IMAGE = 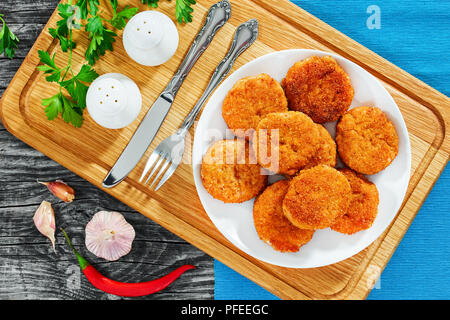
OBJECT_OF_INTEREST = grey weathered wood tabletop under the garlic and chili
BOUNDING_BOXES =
[0,0,214,299]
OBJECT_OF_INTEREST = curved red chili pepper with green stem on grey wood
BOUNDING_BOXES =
[60,228,195,297]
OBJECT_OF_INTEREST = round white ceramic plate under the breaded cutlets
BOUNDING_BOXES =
[192,49,411,268]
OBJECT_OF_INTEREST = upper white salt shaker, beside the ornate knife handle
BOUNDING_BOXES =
[123,10,179,66]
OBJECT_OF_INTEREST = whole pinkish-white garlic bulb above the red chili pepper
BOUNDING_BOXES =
[85,211,135,261]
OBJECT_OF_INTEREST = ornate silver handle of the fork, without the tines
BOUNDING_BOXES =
[179,19,258,133]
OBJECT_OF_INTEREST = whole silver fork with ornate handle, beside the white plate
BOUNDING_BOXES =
[139,19,258,191]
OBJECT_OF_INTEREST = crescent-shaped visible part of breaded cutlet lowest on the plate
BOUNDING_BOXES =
[253,180,314,252]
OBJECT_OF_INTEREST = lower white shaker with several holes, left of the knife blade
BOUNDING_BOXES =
[86,73,142,129]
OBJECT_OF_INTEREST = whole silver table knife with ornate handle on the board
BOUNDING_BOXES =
[102,0,231,188]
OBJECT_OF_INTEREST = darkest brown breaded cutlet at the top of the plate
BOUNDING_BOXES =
[281,56,354,123]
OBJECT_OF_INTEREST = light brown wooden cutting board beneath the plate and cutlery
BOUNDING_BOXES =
[0,0,450,299]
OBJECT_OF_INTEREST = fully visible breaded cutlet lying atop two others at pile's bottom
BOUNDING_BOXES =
[283,165,351,230]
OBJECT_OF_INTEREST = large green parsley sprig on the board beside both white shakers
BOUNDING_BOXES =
[37,0,138,127]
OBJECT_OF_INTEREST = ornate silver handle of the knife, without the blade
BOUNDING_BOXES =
[163,0,231,101]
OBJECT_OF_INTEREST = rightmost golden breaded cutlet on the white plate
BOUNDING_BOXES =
[336,106,398,174]
